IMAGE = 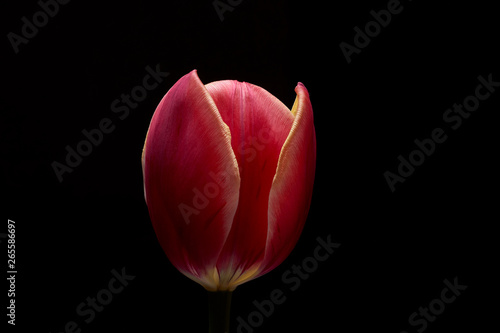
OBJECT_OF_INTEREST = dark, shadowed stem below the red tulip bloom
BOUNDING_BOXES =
[208,291,233,333]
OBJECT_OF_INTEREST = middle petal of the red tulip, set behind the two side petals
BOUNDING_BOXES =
[206,81,294,289]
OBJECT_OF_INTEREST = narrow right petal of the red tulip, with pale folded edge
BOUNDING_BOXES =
[258,82,316,276]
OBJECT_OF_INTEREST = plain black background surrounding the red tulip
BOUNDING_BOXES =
[0,0,500,333]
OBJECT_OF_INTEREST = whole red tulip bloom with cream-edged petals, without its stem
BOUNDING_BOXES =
[142,70,316,332]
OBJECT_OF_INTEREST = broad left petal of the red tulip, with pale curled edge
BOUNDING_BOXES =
[143,70,240,290]
